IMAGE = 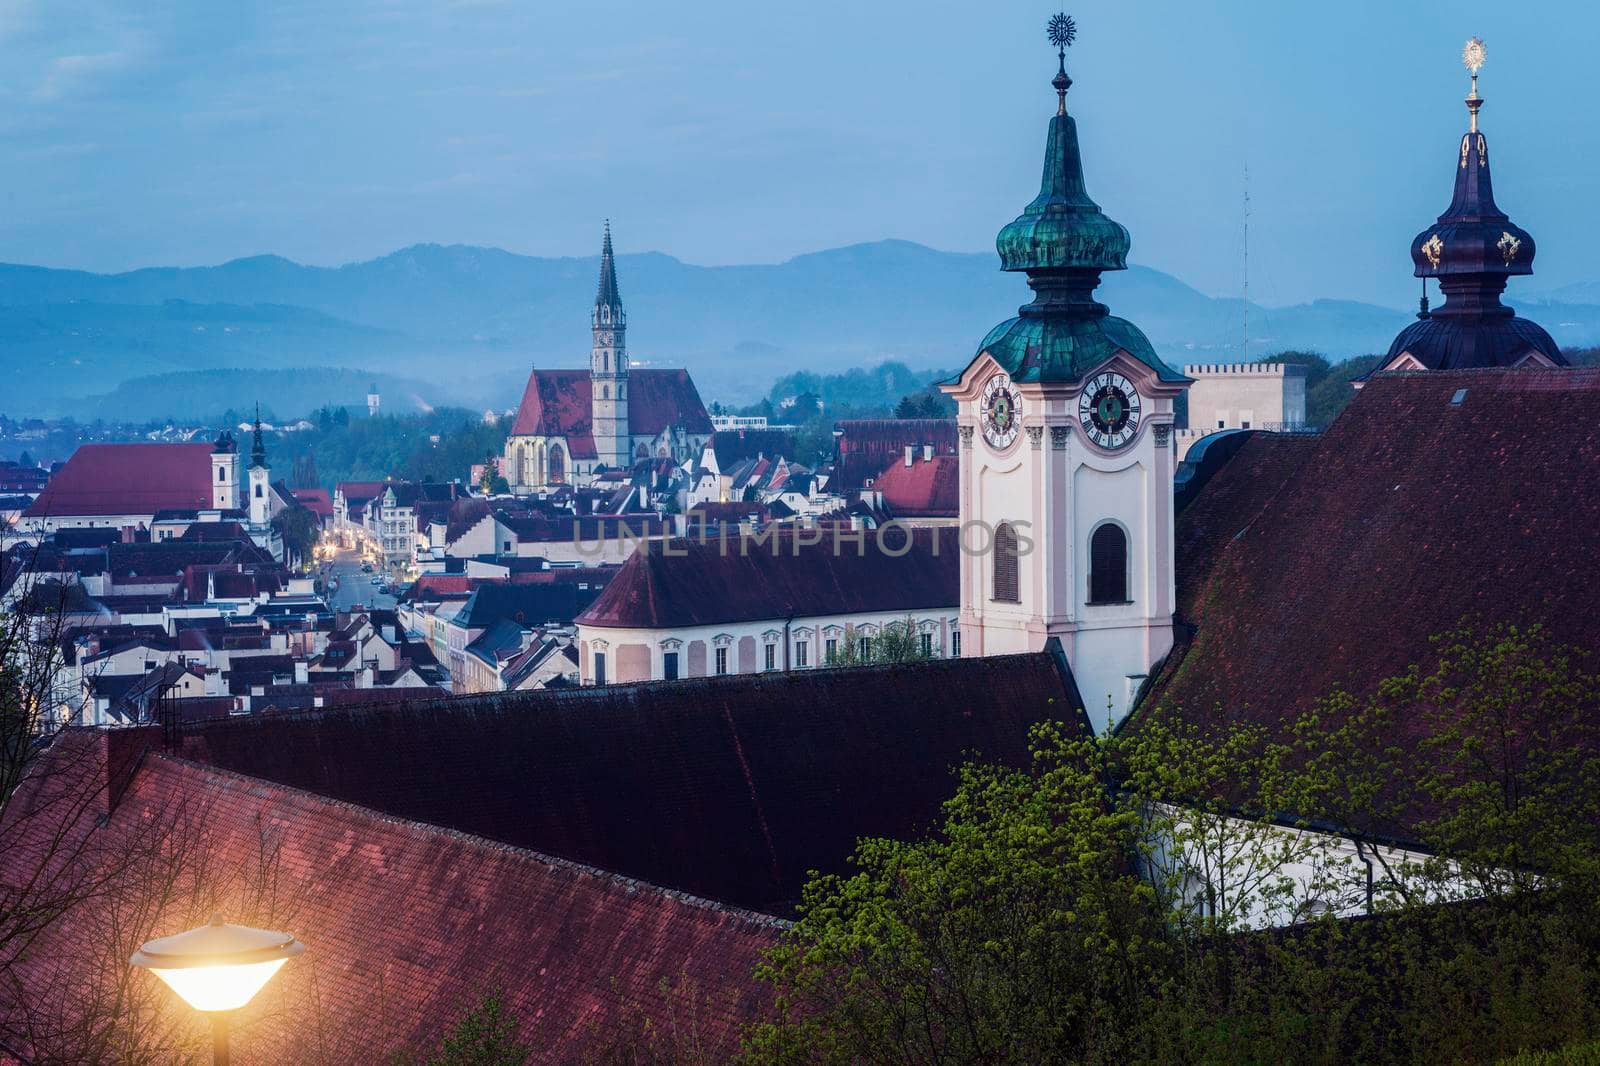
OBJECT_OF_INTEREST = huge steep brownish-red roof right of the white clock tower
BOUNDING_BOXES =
[1134,370,1600,832]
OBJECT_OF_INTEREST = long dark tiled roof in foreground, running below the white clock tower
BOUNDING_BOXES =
[168,653,1077,915]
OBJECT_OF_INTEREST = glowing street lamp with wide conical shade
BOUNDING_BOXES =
[130,914,306,1066]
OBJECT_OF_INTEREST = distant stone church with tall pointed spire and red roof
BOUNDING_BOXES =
[502,222,712,493]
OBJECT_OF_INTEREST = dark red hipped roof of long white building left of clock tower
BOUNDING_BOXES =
[578,528,962,629]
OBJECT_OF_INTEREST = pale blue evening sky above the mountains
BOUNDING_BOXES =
[0,0,1600,307]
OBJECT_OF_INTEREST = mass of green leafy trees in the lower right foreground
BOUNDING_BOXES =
[746,626,1600,1063]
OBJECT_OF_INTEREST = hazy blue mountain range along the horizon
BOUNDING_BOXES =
[0,240,1600,416]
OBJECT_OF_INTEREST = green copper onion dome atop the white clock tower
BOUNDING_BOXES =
[978,36,1187,383]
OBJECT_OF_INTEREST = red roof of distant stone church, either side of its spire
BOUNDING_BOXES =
[510,370,710,459]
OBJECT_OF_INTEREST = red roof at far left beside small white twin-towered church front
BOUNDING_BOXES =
[22,443,211,519]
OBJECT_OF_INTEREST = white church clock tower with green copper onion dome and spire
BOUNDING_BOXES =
[941,14,1190,730]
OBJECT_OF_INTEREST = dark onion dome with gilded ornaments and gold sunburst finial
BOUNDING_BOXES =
[1381,42,1566,370]
